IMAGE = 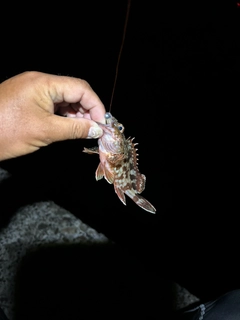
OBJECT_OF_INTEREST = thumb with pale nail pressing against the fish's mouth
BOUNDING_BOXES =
[44,114,103,142]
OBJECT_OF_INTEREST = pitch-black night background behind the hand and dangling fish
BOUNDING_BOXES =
[0,0,240,310]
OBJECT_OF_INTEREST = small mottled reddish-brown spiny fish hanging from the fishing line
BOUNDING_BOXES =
[83,112,156,213]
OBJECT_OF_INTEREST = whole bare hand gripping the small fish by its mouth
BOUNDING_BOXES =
[0,71,106,160]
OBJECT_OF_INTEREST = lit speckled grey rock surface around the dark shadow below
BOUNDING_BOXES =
[0,168,198,320]
